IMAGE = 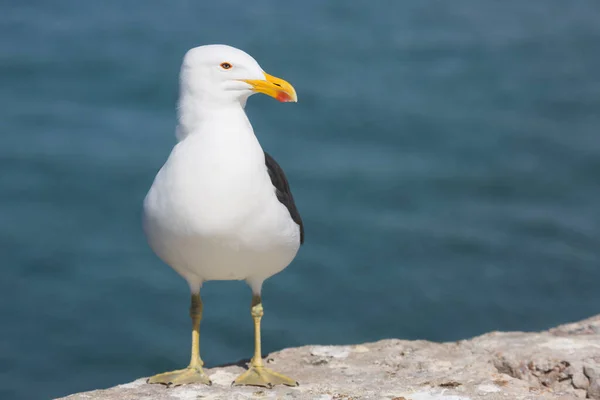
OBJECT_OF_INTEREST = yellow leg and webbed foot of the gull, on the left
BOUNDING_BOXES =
[147,294,211,386]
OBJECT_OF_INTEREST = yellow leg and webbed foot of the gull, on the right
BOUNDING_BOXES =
[233,295,298,388]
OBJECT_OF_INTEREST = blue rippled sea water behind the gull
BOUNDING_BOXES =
[0,0,600,399]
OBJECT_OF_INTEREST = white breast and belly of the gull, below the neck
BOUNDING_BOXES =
[144,115,300,287]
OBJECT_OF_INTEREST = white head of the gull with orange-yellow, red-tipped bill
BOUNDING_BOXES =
[180,44,298,107]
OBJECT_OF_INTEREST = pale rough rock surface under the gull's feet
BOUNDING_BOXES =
[57,315,600,400]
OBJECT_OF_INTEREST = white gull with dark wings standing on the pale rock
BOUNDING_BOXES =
[143,45,304,388]
